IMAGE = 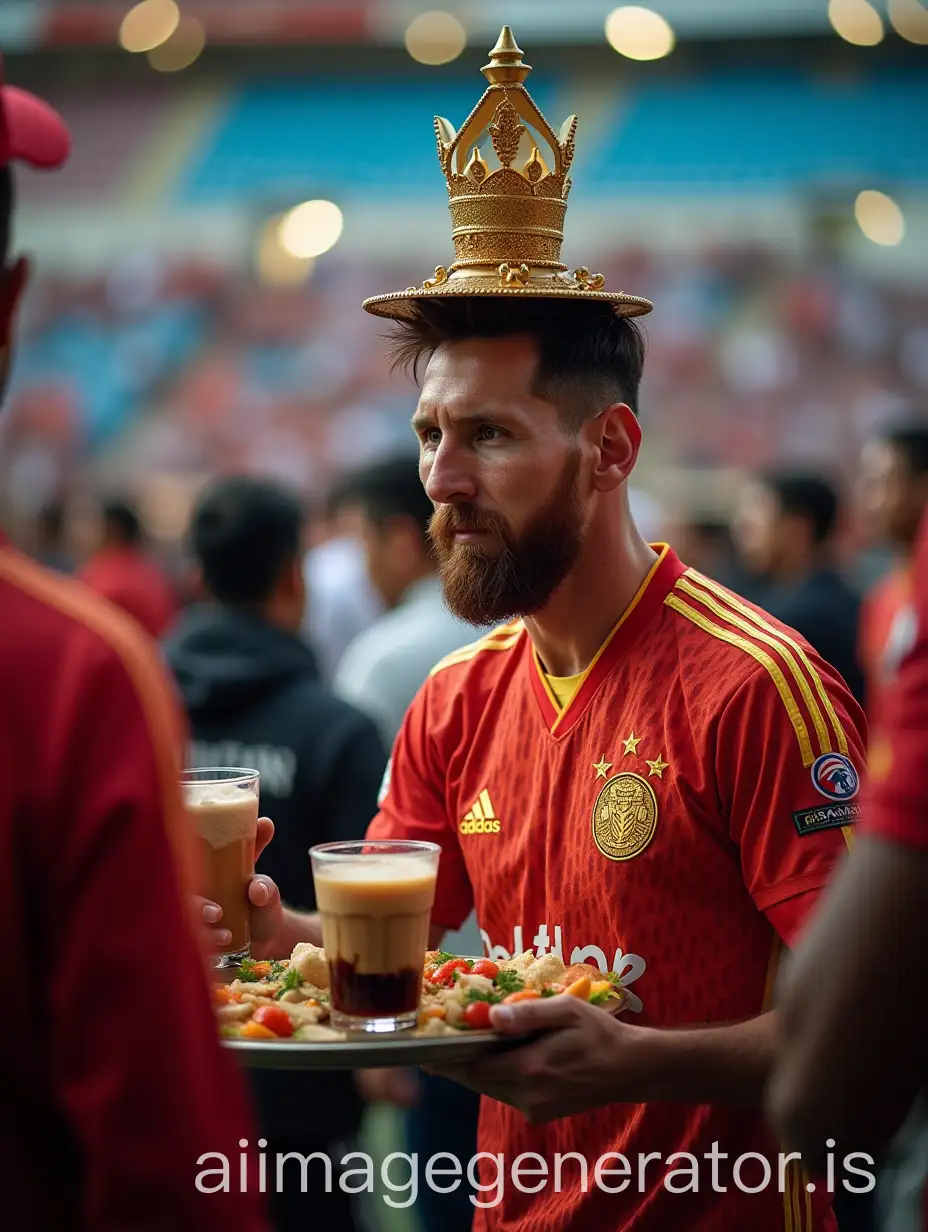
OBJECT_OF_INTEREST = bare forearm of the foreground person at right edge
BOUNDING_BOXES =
[768,835,928,1162]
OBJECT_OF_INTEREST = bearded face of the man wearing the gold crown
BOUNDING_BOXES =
[413,338,587,625]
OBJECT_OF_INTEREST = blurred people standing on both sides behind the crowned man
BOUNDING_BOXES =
[10,408,928,1232]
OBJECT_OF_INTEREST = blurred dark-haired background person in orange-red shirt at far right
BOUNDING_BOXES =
[858,421,928,731]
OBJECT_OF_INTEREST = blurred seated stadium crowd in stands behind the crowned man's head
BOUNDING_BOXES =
[7,244,928,529]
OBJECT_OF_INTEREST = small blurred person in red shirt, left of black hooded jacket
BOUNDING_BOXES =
[78,498,177,638]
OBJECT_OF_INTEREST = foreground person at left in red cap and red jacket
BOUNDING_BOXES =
[0,52,266,1232]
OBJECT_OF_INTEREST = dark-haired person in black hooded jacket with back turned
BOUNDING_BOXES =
[164,476,387,1232]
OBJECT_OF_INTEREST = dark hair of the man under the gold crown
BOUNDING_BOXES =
[391,296,645,431]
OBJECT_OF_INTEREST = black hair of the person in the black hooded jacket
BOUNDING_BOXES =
[189,476,304,606]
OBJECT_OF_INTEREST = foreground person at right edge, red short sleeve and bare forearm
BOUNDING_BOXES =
[768,505,928,1228]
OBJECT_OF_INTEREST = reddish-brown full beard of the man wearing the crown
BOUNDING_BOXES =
[429,450,584,625]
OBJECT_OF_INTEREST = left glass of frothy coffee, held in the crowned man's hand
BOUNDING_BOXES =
[181,766,259,970]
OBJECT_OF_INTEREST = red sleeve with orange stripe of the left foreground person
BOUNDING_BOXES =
[48,634,266,1232]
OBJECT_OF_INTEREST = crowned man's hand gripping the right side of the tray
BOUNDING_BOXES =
[425,995,656,1125]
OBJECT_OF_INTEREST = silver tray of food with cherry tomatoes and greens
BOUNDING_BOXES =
[213,942,626,1069]
